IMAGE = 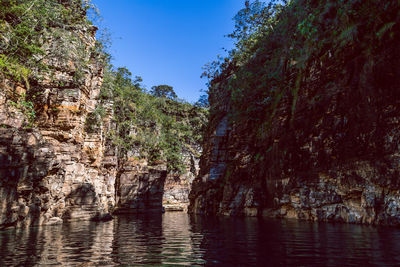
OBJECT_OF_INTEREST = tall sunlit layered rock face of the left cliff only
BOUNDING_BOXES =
[0,5,117,227]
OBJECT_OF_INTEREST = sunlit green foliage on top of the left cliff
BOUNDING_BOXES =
[0,0,97,127]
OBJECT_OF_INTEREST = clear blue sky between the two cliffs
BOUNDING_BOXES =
[92,0,244,102]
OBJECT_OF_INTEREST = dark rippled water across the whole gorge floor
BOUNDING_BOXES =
[0,213,400,266]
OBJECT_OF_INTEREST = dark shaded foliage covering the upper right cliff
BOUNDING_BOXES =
[205,0,400,180]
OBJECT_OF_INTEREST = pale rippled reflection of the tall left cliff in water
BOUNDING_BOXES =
[0,221,114,266]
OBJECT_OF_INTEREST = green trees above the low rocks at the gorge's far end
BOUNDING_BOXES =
[98,68,207,172]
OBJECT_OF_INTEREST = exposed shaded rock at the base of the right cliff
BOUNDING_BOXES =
[190,103,400,225]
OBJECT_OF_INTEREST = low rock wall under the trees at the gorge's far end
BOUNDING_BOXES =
[114,152,199,214]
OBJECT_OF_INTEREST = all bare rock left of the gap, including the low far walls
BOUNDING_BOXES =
[0,1,203,228]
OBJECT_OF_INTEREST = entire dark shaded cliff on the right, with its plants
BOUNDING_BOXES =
[189,1,400,225]
